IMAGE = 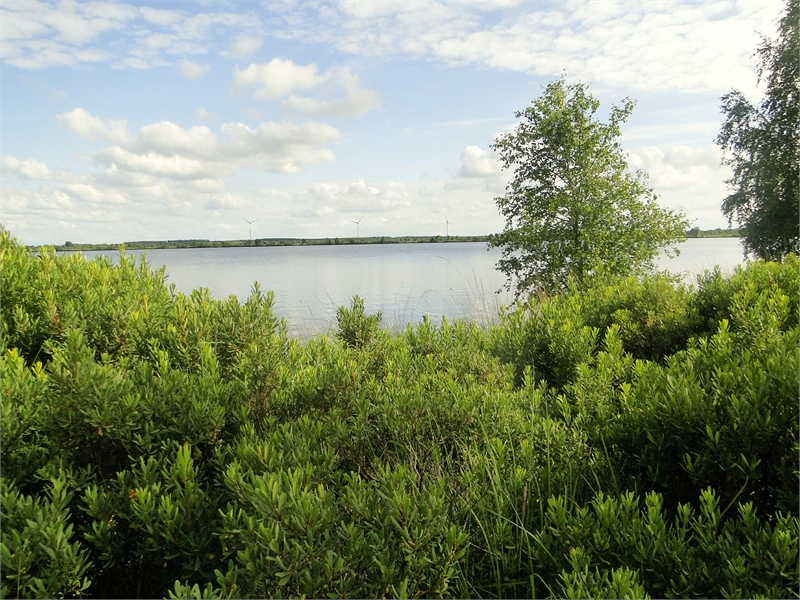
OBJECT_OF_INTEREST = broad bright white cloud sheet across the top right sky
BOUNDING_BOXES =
[268,0,783,94]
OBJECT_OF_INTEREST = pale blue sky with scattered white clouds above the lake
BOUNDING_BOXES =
[0,0,783,244]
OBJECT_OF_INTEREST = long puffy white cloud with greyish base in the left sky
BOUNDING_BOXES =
[58,108,341,180]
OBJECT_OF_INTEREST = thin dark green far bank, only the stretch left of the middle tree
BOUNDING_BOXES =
[50,235,490,252]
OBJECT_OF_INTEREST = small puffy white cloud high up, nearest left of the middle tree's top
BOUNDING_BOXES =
[234,58,381,118]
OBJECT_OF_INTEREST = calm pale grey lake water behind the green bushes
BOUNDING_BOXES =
[73,238,744,338]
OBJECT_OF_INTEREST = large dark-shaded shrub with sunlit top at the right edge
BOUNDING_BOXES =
[592,321,799,513]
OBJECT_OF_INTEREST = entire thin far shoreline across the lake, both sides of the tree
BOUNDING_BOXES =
[36,227,741,252]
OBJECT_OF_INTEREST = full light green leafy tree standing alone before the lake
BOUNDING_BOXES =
[490,77,688,294]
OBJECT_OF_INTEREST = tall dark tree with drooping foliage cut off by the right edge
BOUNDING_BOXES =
[716,0,800,260]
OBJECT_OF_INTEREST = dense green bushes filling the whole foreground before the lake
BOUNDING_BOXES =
[0,227,800,598]
